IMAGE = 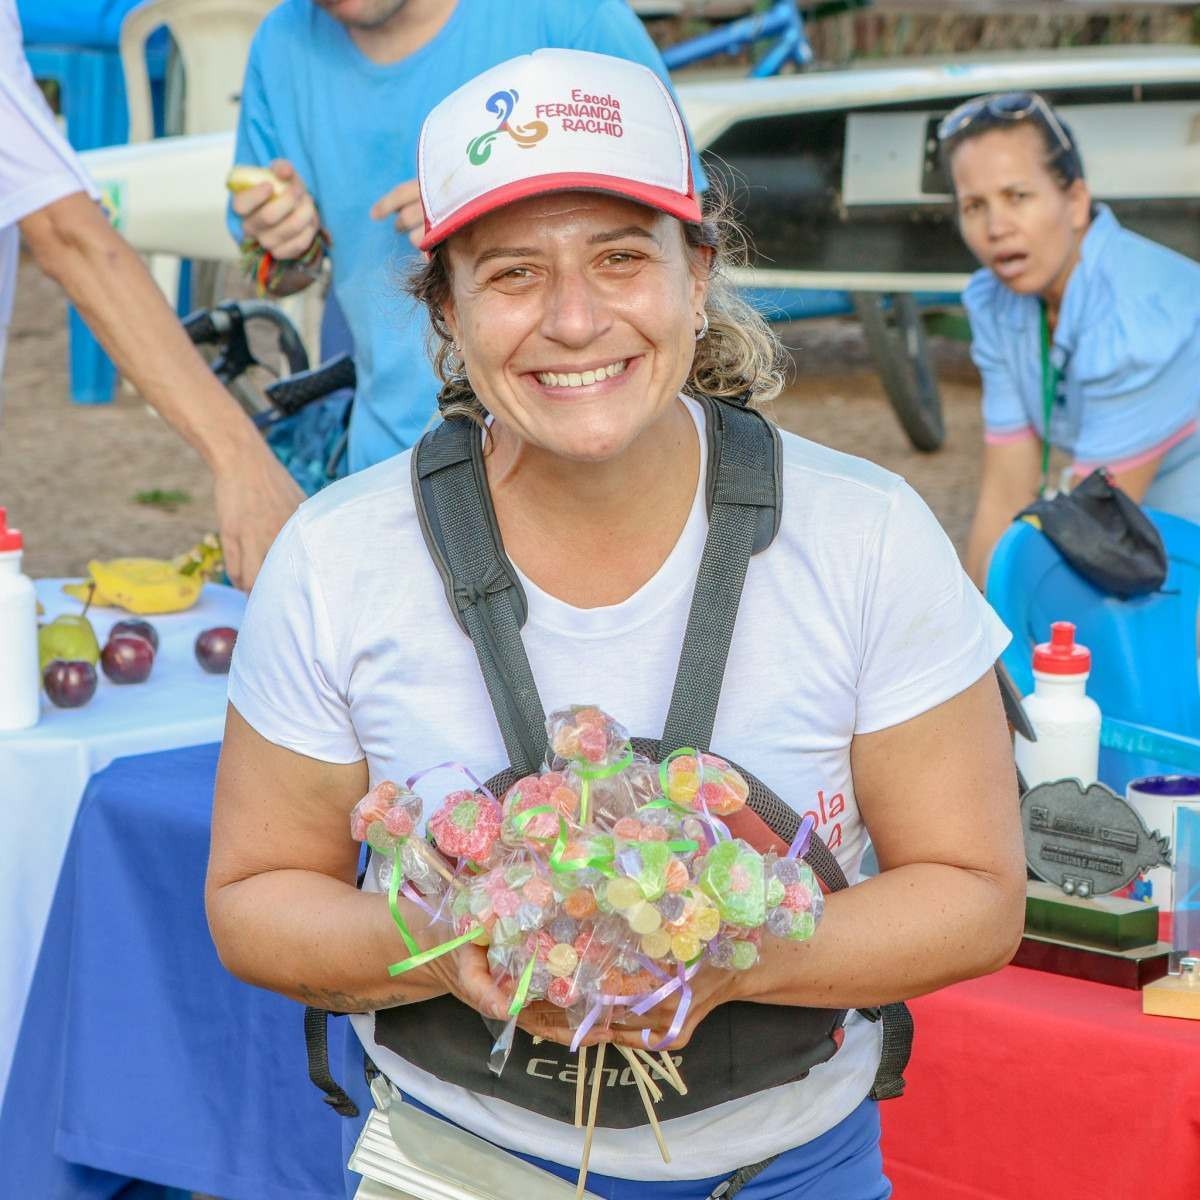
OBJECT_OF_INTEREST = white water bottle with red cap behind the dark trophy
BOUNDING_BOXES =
[1015,620,1100,788]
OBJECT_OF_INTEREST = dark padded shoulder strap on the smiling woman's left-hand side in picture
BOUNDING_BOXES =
[413,419,546,774]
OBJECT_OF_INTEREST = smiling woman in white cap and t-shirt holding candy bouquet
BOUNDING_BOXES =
[208,50,1024,1200]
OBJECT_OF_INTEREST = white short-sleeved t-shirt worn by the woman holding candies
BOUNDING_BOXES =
[229,402,1008,1180]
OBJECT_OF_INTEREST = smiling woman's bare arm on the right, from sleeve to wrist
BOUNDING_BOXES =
[744,671,1025,1008]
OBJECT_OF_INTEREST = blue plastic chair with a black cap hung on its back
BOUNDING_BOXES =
[986,509,1200,790]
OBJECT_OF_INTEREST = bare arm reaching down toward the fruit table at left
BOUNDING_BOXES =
[20,192,302,588]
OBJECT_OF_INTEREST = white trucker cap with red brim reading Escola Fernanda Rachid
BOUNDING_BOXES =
[416,49,701,250]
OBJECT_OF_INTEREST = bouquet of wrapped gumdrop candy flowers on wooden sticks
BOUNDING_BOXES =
[350,706,823,1178]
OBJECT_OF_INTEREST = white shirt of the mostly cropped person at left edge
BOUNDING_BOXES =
[0,0,98,395]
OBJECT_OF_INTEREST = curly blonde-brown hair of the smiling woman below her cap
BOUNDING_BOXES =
[406,181,785,424]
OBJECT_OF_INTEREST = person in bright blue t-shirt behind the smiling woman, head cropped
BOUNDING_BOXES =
[229,0,700,472]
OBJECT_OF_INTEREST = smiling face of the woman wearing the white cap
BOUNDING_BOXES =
[446,192,707,463]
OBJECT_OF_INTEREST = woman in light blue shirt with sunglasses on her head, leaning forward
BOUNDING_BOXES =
[938,92,1200,586]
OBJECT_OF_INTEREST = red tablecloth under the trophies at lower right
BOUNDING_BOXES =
[880,967,1200,1200]
